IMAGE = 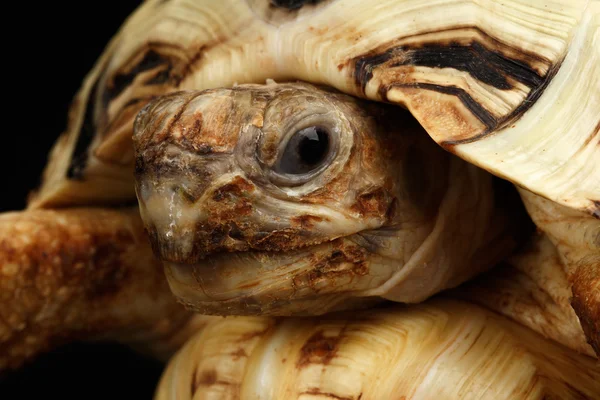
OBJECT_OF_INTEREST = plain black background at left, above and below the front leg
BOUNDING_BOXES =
[0,0,163,400]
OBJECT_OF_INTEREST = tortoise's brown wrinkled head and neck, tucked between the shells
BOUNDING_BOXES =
[134,83,514,315]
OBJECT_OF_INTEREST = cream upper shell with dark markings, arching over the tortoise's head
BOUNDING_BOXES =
[30,0,600,216]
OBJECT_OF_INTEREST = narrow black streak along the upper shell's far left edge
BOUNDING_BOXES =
[67,78,100,180]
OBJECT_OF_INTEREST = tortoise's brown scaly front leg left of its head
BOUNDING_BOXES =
[0,208,214,370]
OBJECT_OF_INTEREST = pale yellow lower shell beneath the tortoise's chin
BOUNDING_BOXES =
[156,299,600,400]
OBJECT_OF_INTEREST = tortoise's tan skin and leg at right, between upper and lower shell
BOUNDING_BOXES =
[453,190,600,356]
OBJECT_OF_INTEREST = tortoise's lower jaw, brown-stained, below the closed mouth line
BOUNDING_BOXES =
[159,234,392,315]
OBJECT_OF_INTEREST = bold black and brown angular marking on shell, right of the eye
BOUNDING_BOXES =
[349,27,560,146]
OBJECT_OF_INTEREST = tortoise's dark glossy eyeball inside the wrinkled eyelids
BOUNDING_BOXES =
[275,126,331,175]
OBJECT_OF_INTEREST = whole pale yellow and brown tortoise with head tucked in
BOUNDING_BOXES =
[0,0,600,399]
